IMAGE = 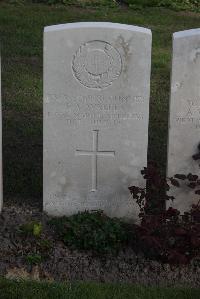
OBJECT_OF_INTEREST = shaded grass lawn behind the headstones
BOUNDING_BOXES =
[0,2,200,203]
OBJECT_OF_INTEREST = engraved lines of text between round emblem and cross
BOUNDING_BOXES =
[46,94,145,127]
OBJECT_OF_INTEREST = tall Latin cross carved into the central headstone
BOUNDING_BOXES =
[75,130,115,192]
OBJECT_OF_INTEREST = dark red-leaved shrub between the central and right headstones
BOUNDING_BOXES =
[129,146,200,264]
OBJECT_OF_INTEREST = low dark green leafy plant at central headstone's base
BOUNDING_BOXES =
[50,211,128,254]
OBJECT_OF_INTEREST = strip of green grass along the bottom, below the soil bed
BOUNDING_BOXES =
[0,279,200,299]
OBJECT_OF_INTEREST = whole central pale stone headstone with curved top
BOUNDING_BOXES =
[44,23,151,220]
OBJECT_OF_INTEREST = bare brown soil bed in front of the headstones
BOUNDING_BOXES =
[0,205,200,287]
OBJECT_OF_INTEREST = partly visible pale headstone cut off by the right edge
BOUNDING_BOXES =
[168,29,200,212]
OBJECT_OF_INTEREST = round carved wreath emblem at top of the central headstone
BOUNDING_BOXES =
[72,40,122,89]
